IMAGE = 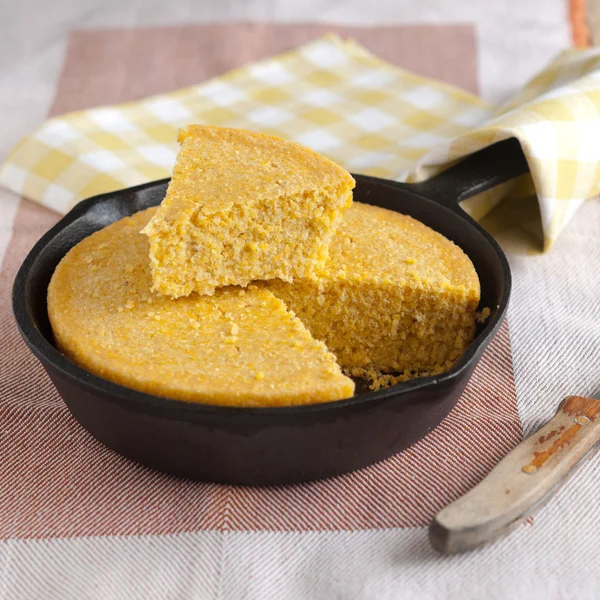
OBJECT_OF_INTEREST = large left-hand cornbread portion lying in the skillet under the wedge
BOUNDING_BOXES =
[48,208,354,406]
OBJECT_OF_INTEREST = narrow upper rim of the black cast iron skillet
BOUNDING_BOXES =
[12,174,512,420]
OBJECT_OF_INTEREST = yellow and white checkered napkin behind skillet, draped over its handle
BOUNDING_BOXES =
[0,36,600,248]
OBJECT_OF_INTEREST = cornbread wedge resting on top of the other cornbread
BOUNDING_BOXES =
[144,125,354,298]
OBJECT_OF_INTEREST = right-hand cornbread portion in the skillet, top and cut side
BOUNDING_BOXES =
[265,202,480,378]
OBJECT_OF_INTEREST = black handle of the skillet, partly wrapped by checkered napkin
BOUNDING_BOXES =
[411,138,529,207]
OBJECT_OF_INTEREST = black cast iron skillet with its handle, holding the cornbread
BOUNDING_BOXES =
[13,139,527,485]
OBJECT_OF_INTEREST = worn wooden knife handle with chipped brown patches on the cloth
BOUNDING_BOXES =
[429,396,600,554]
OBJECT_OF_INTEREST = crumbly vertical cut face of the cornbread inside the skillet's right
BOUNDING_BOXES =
[268,280,479,376]
